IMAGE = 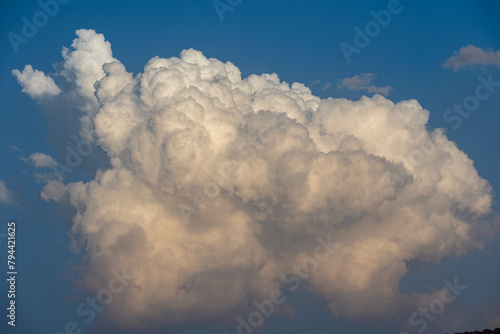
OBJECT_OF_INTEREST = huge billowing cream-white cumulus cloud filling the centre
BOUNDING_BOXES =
[15,30,492,331]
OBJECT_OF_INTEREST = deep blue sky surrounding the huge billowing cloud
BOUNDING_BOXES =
[0,0,500,334]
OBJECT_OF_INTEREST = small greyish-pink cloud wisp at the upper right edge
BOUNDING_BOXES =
[443,44,500,71]
